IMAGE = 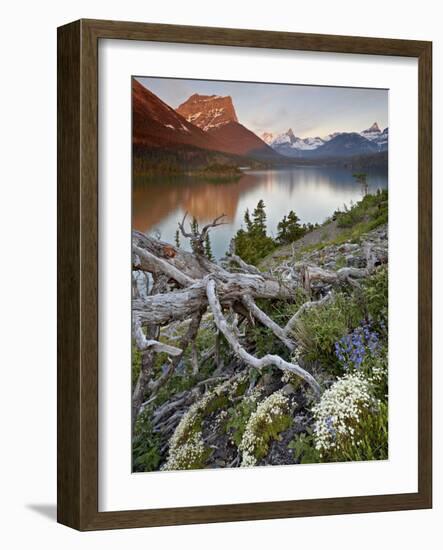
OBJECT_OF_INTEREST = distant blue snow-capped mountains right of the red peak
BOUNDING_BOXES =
[261,122,389,158]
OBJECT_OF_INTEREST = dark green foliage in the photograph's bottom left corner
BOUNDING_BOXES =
[132,410,162,472]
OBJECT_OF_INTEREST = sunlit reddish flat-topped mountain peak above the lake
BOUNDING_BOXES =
[177,94,238,131]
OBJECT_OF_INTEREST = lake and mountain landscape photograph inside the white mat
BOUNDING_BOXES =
[131,76,389,472]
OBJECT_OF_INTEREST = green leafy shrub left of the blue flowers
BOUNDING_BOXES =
[294,293,363,374]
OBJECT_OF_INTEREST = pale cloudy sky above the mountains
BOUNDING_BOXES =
[137,77,388,138]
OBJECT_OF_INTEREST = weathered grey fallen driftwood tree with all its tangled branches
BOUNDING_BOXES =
[132,215,384,425]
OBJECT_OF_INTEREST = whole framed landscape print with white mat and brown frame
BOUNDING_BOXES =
[58,20,432,530]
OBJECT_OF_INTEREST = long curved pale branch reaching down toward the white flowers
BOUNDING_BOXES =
[206,279,321,399]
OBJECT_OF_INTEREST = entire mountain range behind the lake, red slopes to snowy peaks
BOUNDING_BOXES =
[132,79,388,171]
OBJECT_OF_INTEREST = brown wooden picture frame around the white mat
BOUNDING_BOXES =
[58,20,432,531]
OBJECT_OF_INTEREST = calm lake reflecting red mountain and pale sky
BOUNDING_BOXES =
[133,166,388,258]
